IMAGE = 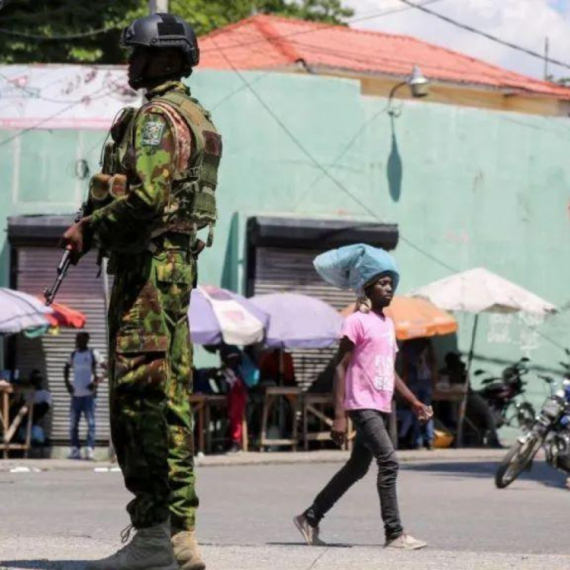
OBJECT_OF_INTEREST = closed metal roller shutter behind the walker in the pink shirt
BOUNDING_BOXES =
[253,247,355,388]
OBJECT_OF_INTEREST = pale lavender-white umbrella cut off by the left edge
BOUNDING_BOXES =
[0,287,53,334]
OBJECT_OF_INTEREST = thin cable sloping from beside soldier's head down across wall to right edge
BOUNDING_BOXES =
[213,36,565,350]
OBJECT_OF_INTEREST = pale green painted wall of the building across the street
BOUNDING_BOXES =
[0,71,570,408]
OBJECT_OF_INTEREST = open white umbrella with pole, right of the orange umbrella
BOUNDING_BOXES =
[412,267,556,444]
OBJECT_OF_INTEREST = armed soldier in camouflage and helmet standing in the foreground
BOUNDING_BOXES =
[64,14,222,570]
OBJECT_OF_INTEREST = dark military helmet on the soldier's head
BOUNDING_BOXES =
[121,13,200,69]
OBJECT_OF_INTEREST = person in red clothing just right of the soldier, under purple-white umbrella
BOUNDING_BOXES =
[220,344,259,454]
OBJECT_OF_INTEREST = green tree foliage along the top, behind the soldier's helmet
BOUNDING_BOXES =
[0,0,353,64]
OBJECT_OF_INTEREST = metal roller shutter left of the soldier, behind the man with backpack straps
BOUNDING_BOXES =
[16,247,109,445]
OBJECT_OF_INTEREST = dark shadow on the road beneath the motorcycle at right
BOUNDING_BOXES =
[401,461,566,489]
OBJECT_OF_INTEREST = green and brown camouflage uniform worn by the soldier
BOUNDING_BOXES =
[90,82,221,530]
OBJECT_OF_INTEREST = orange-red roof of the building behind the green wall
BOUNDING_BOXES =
[200,15,570,100]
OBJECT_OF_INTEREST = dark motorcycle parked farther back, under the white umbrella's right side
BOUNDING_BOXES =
[467,357,536,442]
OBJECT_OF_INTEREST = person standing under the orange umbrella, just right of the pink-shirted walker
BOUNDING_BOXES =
[402,338,437,450]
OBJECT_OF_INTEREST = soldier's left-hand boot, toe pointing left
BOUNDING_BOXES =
[85,521,178,570]
